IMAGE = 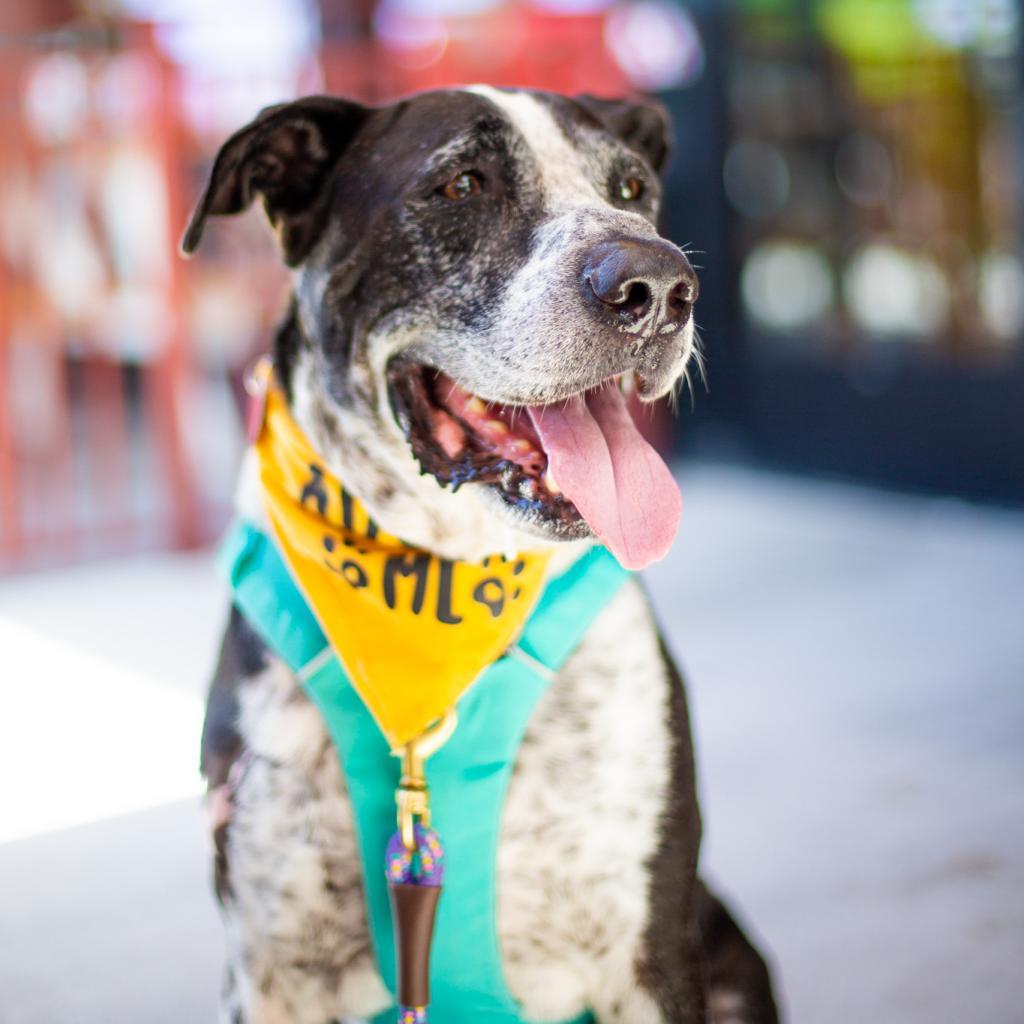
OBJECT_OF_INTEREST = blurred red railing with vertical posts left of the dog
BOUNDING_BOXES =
[0,29,203,566]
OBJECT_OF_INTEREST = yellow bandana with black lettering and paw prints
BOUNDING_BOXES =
[249,370,549,748]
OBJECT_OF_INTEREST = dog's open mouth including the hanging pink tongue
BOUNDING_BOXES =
[388,360,681,568]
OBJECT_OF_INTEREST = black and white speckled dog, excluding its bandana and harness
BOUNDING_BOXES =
[183,87,777,1024]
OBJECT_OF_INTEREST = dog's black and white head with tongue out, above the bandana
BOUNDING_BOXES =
[183,87,697,565]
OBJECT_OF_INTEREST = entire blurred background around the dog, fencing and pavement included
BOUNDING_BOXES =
[0,0,1024,1024]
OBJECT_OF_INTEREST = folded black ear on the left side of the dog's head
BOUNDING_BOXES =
[181,96,370,266]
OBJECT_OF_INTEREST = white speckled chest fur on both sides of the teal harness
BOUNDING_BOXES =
[228,584,672,1020]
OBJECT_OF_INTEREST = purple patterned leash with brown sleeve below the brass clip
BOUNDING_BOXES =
[384,823,444,1024]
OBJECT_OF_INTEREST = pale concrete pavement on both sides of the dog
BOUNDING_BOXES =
[0,467,1024,1024]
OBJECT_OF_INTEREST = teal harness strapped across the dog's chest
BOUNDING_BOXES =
[221,522,629,1024]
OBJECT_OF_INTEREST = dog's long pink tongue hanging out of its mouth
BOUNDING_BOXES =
[529,386,682,569]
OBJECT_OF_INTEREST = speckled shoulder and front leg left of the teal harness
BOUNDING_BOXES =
[203,611,389,1024]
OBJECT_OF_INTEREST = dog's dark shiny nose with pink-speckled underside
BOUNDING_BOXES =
[583,239,697,324]
